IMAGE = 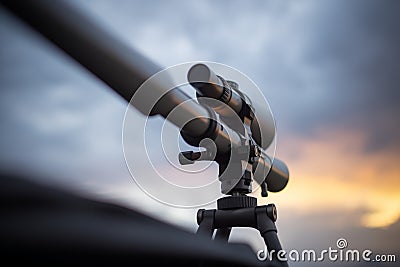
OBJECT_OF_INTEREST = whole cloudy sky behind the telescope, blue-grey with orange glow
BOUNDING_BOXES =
[0,0,400,266]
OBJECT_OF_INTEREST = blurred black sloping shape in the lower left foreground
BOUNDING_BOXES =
[0,174,266,266]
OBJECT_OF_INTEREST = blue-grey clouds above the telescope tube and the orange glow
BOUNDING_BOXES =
[74,1,400,155]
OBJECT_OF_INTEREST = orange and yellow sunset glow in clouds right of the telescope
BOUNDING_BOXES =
[258,130,400,228]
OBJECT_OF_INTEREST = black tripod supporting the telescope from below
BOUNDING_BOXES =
[182,150,288,267]
